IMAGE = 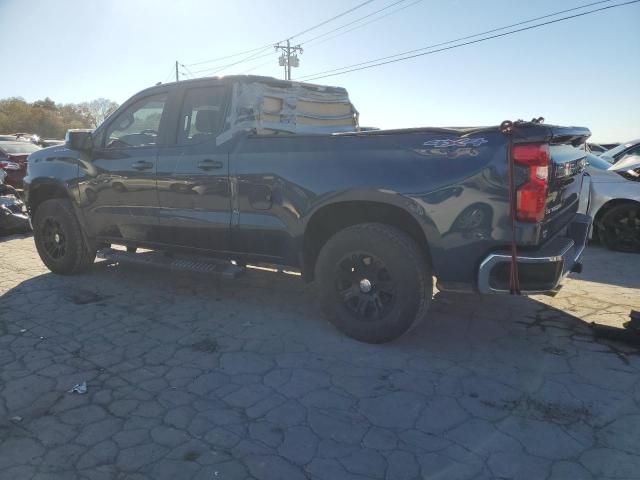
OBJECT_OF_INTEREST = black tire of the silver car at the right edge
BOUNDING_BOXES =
[598,203,640,252]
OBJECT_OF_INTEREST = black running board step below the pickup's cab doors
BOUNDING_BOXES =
[96,248,245,278]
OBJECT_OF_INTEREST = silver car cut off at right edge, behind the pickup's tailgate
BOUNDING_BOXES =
[587,153,640,252]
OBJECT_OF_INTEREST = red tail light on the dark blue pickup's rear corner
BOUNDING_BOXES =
[511,143,549,222]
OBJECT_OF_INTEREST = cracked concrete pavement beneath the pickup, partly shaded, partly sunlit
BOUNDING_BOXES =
[0,236,640,480]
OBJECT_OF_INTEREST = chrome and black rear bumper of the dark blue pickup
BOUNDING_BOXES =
[478,214,591,295]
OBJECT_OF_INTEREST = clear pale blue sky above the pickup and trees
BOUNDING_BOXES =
[0,0,640,142]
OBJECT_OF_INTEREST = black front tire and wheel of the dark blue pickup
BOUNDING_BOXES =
[33,199,96,275]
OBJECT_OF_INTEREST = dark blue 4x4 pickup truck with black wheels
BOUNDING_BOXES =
[24,76,590,342]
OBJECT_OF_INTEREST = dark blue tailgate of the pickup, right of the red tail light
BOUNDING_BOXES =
[542,127,589,239]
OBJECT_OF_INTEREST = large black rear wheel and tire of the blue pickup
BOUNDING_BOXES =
[316,223,433,343]
